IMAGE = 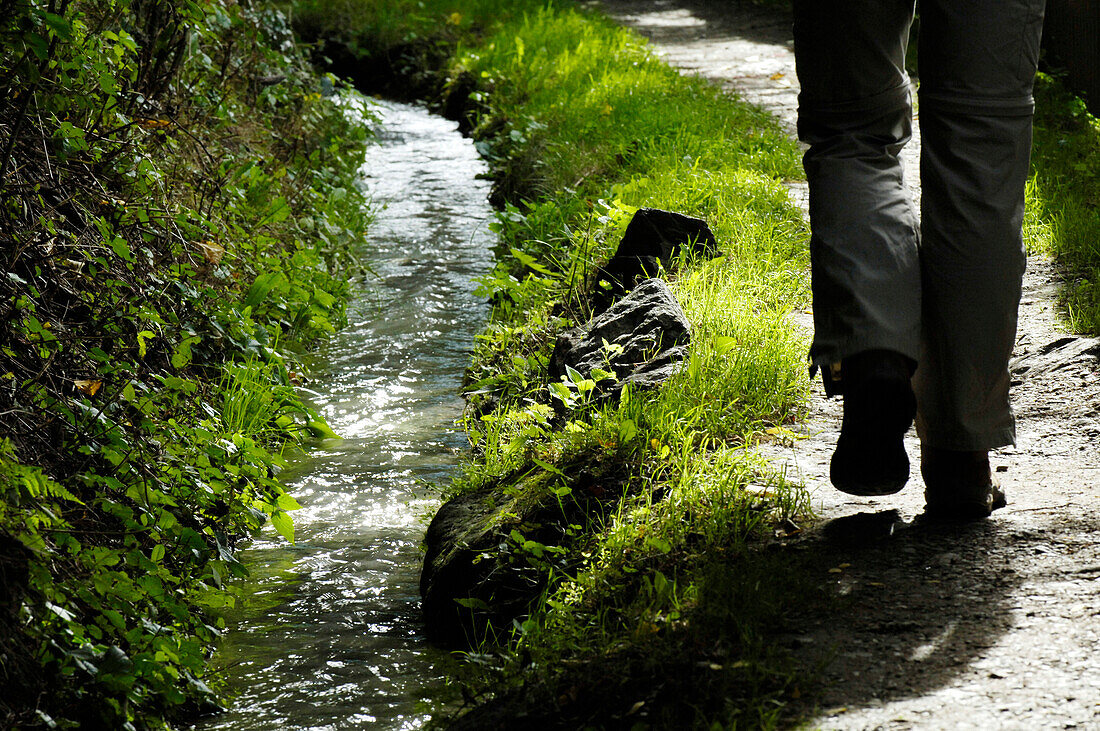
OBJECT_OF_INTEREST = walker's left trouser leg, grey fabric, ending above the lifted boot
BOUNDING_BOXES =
[794,0,921,371]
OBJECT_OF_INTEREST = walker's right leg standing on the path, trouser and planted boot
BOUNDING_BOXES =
[914,0,1044,517]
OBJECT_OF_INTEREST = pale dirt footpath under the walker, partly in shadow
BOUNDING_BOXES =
[602,0,1100,729]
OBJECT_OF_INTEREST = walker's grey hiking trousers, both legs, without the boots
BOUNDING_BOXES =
[794,0,1044,450]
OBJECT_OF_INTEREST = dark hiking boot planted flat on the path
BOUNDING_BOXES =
[921,446,1005,522]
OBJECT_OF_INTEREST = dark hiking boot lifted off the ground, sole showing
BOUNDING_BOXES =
[829,351,916,496]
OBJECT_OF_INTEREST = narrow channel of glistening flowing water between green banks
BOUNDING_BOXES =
[197,102,492,731]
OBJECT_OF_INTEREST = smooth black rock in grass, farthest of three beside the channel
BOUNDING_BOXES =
[593,208,718,312]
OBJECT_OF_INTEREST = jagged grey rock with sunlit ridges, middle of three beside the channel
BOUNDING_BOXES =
[550,279,691,395]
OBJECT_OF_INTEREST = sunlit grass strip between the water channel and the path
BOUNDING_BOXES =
[295,2,822,728]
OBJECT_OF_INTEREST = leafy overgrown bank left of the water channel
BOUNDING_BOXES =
[0,0,370,729]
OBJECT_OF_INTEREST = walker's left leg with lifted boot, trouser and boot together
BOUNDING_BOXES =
[794,0,921,495]
